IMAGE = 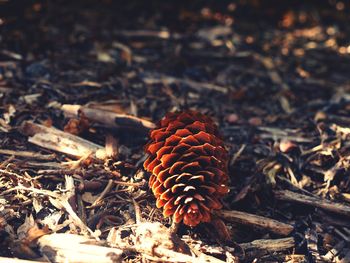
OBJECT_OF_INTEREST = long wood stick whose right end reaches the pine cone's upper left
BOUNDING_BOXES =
[61,104,155,131]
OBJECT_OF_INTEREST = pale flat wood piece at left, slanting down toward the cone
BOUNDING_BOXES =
[20,121,104,158]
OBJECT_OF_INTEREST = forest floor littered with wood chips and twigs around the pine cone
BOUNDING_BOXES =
[0,0,350,262]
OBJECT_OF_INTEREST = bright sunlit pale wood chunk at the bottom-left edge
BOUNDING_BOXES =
[38,234,123,263]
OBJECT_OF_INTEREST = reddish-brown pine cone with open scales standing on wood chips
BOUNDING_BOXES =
[144,111,228,226]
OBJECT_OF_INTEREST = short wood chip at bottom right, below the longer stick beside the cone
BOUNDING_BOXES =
[239,237,295,258]
